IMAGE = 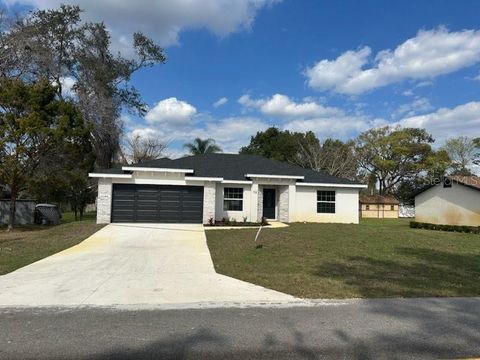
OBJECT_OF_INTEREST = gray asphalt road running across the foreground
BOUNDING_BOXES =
[0,298,480,360]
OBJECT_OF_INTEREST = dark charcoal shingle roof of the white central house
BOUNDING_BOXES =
[98,154,360,185]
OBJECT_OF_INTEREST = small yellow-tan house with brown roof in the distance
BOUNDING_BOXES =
[360,195,400,219]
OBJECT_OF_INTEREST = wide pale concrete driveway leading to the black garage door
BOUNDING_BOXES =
[0,224,298,307]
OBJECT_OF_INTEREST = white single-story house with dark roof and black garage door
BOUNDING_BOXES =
[90,154,366,224]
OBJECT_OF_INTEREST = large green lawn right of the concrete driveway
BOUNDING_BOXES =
[207,219,480,298]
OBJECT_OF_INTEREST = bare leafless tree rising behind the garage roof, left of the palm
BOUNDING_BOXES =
[124,135,167,164]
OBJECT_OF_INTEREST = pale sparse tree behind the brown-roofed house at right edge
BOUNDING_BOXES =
[442,136,480,175]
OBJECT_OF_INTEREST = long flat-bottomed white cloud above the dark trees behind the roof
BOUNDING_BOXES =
[238,94,340,118]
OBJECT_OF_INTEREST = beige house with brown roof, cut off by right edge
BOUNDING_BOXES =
[415,176,480,226]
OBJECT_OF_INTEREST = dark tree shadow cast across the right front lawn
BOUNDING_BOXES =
[314,247,480,297]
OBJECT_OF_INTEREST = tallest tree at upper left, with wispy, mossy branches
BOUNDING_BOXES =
[0,5,166,168]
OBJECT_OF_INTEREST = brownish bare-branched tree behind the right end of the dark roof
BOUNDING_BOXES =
[294,139,358,180]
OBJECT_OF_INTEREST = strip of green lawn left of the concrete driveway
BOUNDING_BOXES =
[0,213,103,275]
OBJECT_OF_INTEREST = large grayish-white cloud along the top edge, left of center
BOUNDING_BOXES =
[5,0,278,49]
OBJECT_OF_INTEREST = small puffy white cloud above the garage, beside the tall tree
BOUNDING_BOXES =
[145,97,197,125]
